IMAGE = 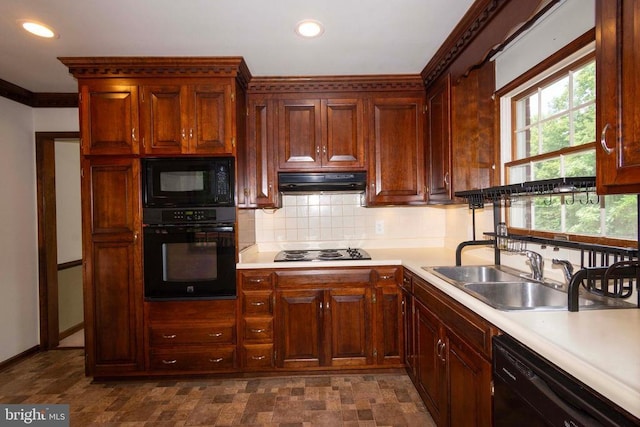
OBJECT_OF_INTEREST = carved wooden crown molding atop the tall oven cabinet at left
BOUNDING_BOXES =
[58,56,251,88]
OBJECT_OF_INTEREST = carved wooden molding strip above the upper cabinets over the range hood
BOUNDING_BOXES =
[248,74,424,93]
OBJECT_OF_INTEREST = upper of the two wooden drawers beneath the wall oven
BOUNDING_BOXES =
[149,324,236,346]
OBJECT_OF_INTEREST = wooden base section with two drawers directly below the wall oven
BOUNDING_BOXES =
[145,300,238,374]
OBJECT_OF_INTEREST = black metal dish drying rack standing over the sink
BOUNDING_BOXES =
[455,177,640,311]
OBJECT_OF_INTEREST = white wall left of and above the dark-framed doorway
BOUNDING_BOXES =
[0,97,79,362]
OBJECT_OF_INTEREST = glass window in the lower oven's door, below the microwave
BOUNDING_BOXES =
[162,241,218,282]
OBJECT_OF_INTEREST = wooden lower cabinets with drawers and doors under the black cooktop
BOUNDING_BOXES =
[238,266,404,371]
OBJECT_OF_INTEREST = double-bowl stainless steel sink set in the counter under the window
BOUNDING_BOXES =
[422,265,635,311]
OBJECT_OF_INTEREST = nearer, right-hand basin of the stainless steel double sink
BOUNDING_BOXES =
[463,281,596,310]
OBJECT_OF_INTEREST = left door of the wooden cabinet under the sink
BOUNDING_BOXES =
[414,301,447,425]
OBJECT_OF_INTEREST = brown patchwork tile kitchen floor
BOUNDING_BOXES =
[0,349,434,427]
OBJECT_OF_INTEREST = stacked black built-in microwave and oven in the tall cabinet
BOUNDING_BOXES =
[142,157,236,301]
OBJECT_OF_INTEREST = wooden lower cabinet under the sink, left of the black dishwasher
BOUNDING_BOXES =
[404,272,498,426]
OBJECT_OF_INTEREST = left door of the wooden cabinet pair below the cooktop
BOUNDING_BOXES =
[275,290,325,368]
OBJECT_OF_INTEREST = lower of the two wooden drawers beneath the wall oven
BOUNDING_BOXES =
[149,346,235,371]
